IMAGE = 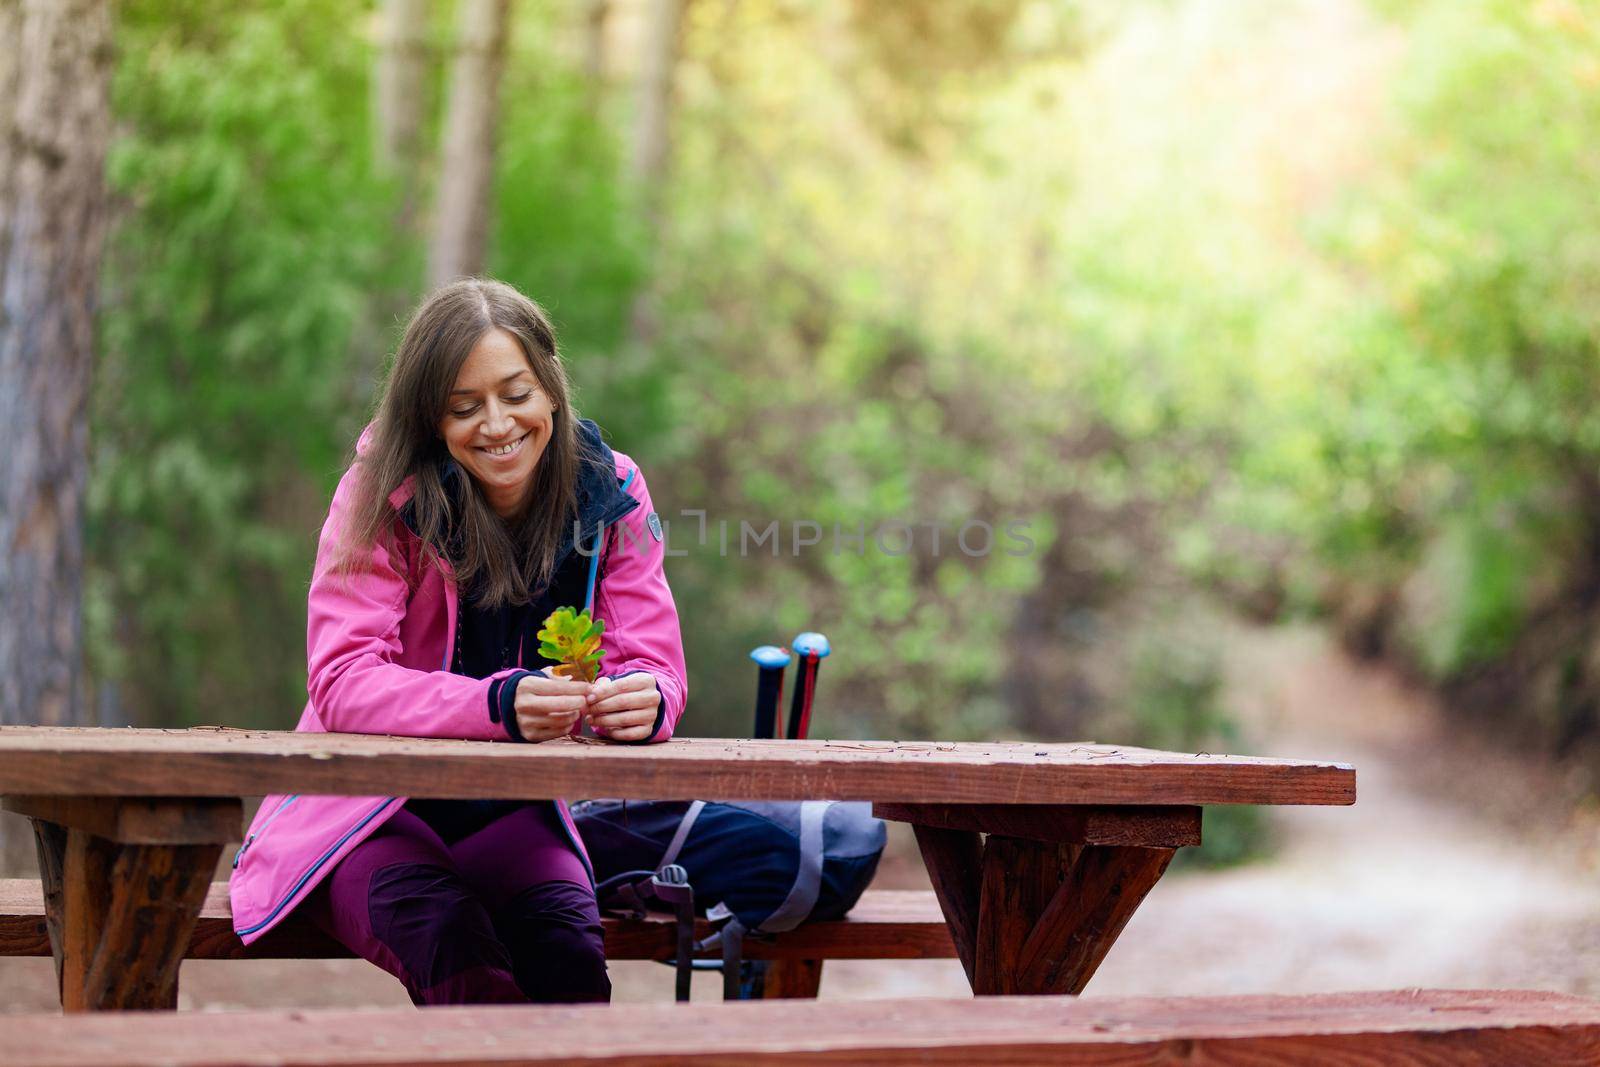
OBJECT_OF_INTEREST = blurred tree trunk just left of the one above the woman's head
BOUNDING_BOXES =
[373,0,427,232]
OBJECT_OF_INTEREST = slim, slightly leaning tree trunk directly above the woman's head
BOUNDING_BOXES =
[427,0,510,286]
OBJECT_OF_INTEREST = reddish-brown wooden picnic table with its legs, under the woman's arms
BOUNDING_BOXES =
[0,726,1355,1011]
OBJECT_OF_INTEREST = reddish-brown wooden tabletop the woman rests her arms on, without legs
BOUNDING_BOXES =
[0,726,1355,805]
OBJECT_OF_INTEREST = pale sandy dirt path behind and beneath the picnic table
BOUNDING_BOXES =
[0,632,1600,1011]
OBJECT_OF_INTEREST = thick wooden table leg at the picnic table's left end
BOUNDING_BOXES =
[6,798,242,1011]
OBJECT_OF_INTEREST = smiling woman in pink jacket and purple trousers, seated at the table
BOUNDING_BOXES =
[230,280,686,1005]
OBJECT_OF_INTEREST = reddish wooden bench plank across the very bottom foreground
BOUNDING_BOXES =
[0,990,1600,1067]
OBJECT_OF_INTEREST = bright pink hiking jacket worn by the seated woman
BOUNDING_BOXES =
[229,441,688,944]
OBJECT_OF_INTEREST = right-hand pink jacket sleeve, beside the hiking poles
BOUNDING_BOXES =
[595,454,688,741]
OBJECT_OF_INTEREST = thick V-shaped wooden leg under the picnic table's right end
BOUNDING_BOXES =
[874,805,1200,993]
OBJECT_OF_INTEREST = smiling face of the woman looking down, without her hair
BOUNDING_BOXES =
[438,330,554,518]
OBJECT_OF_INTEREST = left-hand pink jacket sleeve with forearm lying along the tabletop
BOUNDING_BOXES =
[306,464,517,741]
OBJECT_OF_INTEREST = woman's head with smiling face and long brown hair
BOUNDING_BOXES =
[342,280,585,606]
